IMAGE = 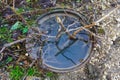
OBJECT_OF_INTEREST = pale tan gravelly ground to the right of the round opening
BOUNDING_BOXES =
[58,0,120,80]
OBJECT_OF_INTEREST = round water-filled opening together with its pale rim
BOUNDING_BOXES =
[27,9,93,72]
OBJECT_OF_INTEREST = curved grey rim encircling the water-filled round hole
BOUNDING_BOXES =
[36,9,95,73]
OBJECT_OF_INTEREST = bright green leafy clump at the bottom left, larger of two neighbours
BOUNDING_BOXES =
[10,66,24,80]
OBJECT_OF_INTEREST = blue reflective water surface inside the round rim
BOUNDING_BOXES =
[38,14,92,69]
